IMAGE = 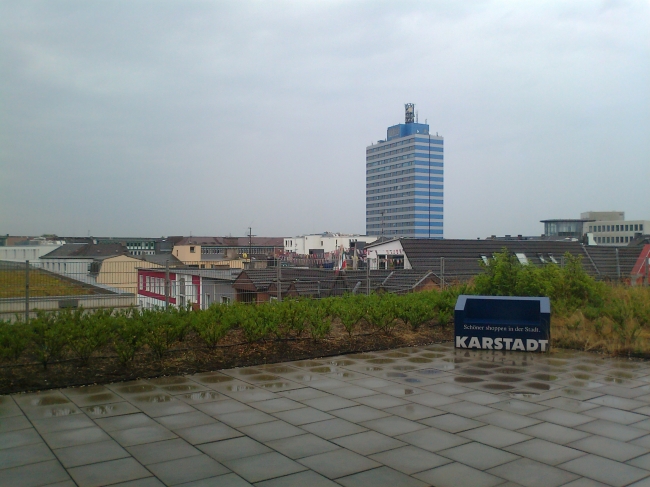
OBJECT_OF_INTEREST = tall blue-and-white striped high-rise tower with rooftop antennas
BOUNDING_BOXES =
[366,103,444,238]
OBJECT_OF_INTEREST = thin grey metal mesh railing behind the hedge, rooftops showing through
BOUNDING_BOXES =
[0,253,649,321]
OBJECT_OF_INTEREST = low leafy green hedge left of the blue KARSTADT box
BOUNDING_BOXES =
[0,291,455,368]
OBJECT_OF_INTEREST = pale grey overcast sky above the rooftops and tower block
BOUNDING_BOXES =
[0,0,650,238]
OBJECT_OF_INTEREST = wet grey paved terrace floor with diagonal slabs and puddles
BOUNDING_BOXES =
[0,344,650,487]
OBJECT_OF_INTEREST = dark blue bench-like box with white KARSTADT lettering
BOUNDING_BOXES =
[454,295,551,352]
